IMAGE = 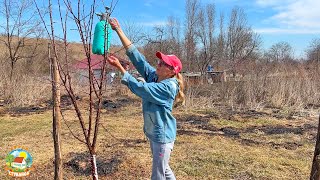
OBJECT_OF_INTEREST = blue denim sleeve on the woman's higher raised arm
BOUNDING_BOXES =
[126,45,156,82]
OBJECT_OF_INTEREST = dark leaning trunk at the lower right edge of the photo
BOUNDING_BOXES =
[310,115,320,180]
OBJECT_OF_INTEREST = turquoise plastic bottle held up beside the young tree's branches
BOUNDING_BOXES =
[92,14,112,55]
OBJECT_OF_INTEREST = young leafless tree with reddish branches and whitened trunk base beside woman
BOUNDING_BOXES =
[34,0,114,180]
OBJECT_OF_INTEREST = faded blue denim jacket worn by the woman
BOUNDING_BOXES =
[121,45,179,143]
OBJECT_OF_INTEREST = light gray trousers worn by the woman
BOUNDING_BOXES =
[150,141,176,180]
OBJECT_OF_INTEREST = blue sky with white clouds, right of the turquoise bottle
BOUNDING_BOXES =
[106,0,320,57]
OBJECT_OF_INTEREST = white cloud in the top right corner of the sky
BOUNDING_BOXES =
[256,0,320,31]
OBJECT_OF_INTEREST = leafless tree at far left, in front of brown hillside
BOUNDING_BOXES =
[0,0,42,81]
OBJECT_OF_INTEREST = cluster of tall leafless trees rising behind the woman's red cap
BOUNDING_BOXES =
[145,0,261,73]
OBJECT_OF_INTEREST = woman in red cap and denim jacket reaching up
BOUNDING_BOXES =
[108,18,184,180]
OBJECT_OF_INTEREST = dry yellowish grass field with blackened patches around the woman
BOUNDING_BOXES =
[0,97,318,180]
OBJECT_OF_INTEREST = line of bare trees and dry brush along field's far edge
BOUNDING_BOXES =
[0,0,320,109]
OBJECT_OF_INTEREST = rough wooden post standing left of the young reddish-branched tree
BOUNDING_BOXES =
[51,57,63,180]
